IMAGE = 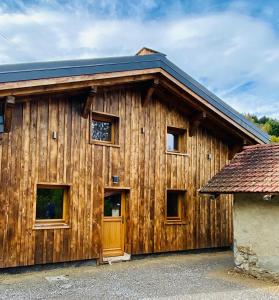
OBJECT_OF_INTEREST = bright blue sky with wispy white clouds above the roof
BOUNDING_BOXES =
[0,0,279,118]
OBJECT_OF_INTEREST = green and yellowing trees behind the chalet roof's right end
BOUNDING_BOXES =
[245,114,279,143]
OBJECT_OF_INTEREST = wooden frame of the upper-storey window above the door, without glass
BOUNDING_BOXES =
[89,111,120,147]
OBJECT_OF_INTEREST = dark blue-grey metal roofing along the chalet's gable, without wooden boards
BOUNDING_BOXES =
[0,53,269,143]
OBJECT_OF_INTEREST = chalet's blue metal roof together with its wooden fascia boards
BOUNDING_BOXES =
[0,53,269,144]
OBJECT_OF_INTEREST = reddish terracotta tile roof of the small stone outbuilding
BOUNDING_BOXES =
[200,144,279,193]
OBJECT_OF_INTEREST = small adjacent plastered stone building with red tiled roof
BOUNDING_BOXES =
[200,144,279,277]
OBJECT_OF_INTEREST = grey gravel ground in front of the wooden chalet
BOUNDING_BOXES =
[0,251,279,300]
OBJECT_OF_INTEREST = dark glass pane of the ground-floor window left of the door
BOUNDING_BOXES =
[36,188,64,220]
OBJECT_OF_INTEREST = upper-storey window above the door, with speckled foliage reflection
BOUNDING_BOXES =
[91,113,119,144]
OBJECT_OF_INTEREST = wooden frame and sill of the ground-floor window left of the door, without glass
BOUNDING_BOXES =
[34,183,70,229]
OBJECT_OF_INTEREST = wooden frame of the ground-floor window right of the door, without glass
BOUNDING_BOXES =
[165,189,186,224]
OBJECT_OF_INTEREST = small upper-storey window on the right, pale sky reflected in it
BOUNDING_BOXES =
[167,127,186,152]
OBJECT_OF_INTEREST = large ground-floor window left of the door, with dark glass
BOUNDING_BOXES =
[36,185,68,223]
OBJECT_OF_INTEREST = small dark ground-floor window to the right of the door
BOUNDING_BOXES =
[166,191,185,221]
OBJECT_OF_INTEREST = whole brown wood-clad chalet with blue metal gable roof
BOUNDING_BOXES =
[0,48,268,268]
